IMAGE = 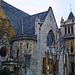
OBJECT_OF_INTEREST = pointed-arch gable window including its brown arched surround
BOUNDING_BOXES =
[47,29,55,46]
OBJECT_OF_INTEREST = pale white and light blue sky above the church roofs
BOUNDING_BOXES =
[4,0,75,27]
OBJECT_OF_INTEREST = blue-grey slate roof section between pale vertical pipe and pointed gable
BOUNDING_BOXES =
[23,11,48,35]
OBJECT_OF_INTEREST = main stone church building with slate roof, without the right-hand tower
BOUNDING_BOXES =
[0,0,74,75]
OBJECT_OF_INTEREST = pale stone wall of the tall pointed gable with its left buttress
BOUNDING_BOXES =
[36,9,58,75]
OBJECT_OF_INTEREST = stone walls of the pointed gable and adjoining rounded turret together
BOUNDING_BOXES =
[13,8,58,75]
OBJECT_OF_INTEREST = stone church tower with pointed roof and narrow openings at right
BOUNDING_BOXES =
[60,12,75,75]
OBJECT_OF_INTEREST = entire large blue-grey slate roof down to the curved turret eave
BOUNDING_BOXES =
[0,1,48,40]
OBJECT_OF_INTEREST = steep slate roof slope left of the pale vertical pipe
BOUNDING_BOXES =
[0,1,29,34]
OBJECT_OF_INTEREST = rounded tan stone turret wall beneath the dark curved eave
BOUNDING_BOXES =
[13,40,37,75]
